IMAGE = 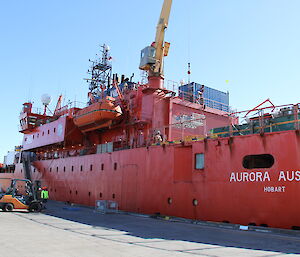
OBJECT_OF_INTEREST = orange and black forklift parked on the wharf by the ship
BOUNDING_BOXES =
[0,178,43,212]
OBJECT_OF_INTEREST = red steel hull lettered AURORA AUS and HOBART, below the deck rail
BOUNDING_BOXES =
[0,131,300,229]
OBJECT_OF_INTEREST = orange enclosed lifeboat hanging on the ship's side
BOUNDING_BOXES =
[74,96,122,132]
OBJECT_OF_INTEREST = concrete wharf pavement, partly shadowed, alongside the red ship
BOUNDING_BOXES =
[0,201,300,257]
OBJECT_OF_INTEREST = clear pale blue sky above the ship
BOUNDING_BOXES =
[0,0,300,159]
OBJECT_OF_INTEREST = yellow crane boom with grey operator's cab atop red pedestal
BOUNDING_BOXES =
[139,0,172,87]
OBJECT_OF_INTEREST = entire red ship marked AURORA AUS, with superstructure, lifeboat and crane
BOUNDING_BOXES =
[0,0,300,229]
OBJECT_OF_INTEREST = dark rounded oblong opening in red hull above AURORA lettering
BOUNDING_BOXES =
[243,154,275,169]
